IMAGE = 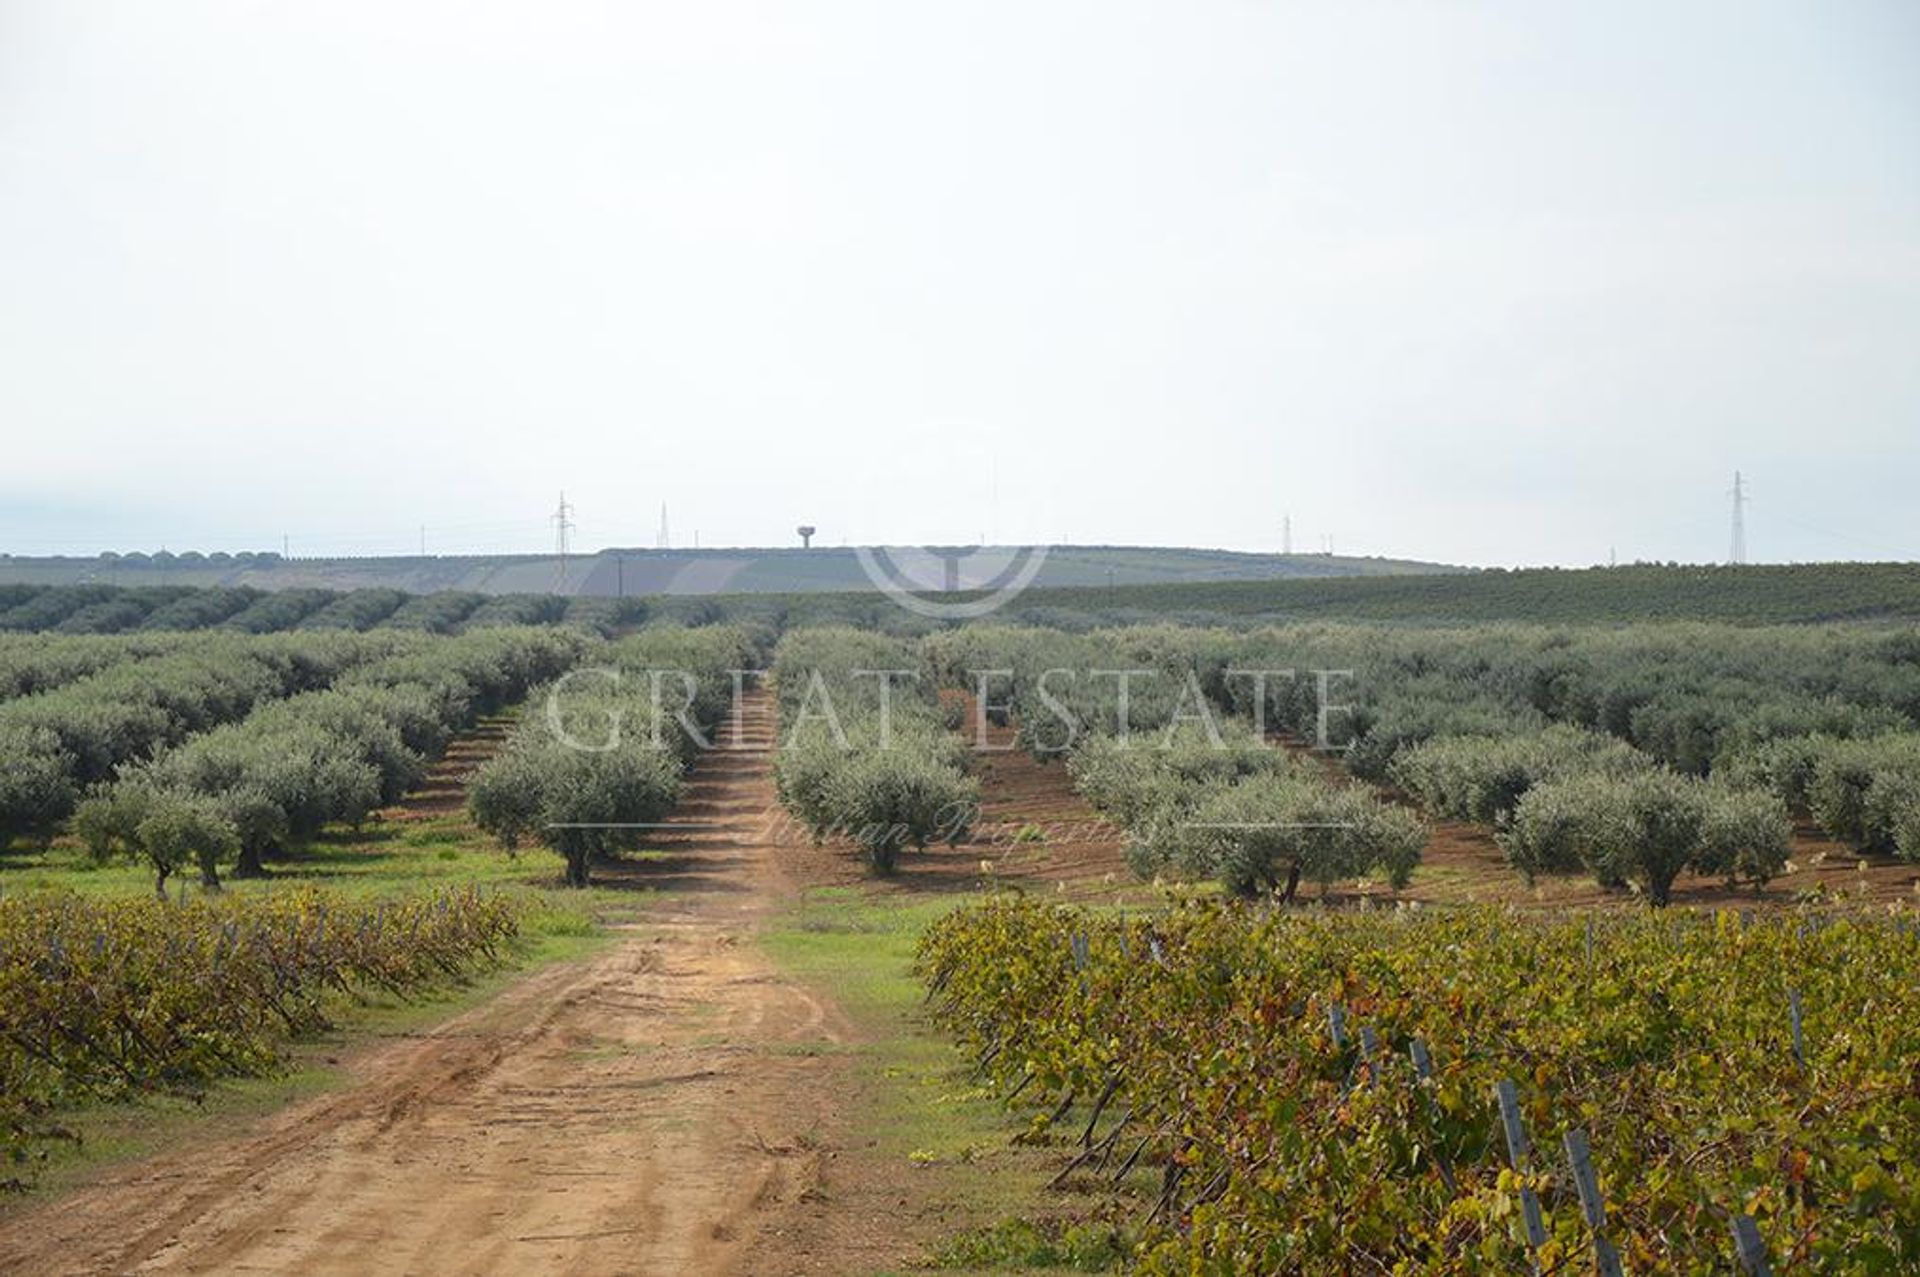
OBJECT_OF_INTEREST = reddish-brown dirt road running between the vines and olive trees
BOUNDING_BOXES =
[0,697,860,1275]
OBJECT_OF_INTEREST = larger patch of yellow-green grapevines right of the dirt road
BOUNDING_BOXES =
[920,897,1920,1273]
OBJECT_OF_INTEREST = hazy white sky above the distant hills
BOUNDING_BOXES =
[0,0,1920,563]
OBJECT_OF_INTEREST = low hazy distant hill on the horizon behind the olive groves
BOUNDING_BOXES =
[0,545,1469,597]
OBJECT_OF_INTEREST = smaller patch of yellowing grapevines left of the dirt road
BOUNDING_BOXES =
[0,887,518,1187]
